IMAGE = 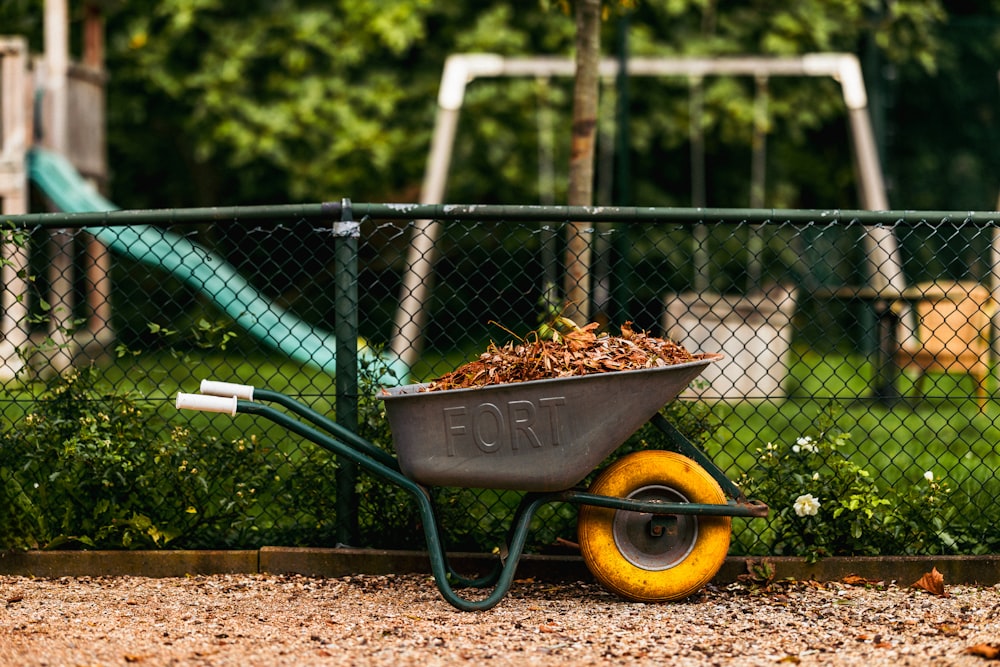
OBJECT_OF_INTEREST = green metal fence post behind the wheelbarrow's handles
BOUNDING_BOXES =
[333,199,360,545]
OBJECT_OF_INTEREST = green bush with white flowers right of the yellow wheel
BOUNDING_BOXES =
[740,404,956,560]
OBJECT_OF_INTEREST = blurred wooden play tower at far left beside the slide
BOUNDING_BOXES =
[0,0,113,380]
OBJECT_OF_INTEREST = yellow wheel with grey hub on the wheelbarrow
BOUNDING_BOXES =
[578,450,732,602]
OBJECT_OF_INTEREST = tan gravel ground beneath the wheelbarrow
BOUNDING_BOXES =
[0,575,1000,667]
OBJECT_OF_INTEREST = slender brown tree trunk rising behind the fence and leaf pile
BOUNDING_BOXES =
[564,0,601,326]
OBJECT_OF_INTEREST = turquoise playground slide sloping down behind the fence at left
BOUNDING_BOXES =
[28,148,409,384]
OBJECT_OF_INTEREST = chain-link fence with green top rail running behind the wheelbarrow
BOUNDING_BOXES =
[0,201,1000,553]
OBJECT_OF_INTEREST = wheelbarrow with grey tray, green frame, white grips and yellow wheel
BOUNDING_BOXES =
[177,355,768,611]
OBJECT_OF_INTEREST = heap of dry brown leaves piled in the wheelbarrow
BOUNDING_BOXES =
[425,322,704,391]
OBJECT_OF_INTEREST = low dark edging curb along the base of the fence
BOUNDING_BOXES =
[0,547,1000,586]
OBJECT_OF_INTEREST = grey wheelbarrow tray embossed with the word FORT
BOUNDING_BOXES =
[380,359,711,491]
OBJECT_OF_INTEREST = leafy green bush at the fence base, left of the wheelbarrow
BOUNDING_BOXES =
[0,369,282,549]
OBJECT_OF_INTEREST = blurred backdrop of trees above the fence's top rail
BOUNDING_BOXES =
[0,0,1000,210]
